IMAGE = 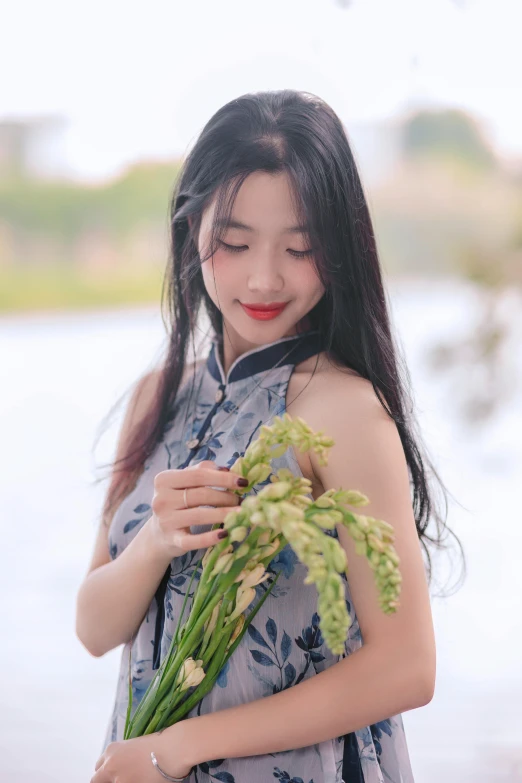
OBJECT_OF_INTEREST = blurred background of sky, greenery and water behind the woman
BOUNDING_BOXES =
[0,0,522,783]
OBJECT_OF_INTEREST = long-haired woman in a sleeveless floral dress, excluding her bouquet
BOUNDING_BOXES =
[77,90,464,783]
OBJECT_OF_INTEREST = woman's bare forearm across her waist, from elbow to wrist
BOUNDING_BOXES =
[160,644,432,771]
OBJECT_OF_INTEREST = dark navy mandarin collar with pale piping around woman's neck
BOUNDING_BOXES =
[206,329,323,385]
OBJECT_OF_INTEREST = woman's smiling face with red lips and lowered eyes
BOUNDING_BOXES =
[198,171,324,350]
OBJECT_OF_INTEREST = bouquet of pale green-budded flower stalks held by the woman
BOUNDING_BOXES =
[124,413,402,739]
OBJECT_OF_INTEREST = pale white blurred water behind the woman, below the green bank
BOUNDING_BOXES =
[0,281,522,783]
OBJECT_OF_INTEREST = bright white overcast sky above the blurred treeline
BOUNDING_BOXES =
[0,0,522,179]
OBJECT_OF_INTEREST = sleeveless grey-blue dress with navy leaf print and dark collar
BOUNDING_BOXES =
[102,330,414,783]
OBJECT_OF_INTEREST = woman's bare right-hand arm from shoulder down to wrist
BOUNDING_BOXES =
[157,373,435,765]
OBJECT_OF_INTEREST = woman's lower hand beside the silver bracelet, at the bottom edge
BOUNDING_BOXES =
[90,731,192,783]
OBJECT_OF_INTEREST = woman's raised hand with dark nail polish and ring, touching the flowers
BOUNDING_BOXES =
[147,460,248,559]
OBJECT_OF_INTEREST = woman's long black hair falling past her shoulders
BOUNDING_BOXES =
[92,90,465,596]
